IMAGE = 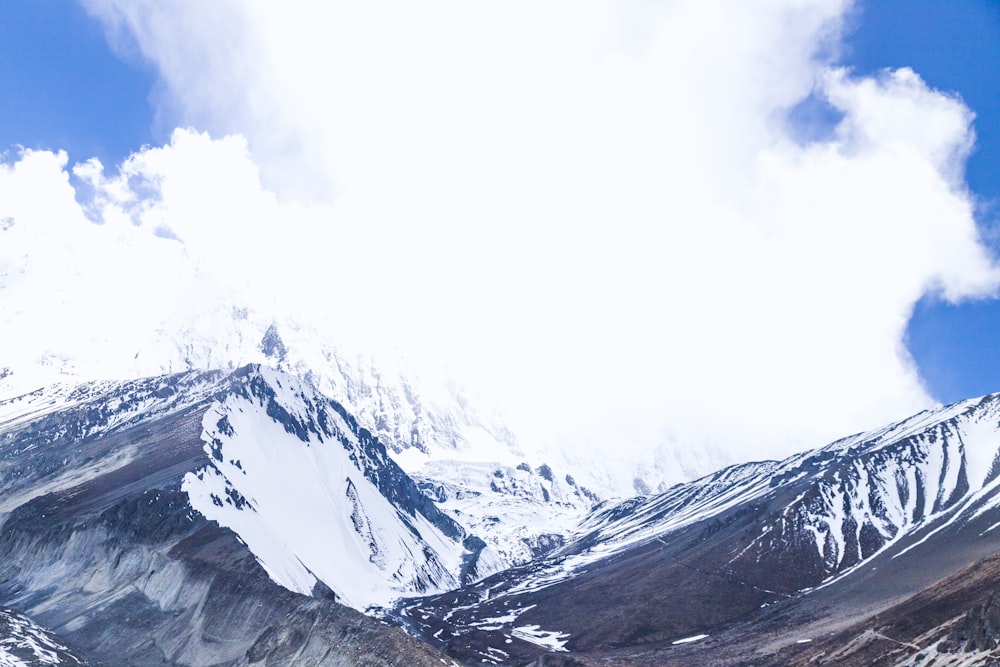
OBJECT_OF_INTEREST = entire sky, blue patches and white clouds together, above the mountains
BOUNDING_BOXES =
[0,0,1000,488]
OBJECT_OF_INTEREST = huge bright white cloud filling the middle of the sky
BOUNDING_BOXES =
[3,0,998,490]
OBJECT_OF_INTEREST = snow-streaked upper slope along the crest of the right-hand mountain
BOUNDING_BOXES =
[504,395,1000,587]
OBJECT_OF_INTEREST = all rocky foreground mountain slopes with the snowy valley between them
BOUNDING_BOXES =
[9,358,1000,667]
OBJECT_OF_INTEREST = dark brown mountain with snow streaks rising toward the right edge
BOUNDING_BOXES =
[398,395,1000,665]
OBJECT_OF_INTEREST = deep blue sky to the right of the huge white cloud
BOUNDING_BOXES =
[847,0,1000,402]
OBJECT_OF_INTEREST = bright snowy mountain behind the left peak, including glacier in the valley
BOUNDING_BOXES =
[0,289,609,565]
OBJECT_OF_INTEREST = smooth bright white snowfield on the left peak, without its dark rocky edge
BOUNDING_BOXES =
[183,368,480,610]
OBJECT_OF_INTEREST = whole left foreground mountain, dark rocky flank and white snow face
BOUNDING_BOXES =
[0,367,468,665]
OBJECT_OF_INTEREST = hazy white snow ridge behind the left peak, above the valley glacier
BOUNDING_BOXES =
[0,300,520,472]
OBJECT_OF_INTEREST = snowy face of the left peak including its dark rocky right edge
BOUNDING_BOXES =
[182,367,499,610]
